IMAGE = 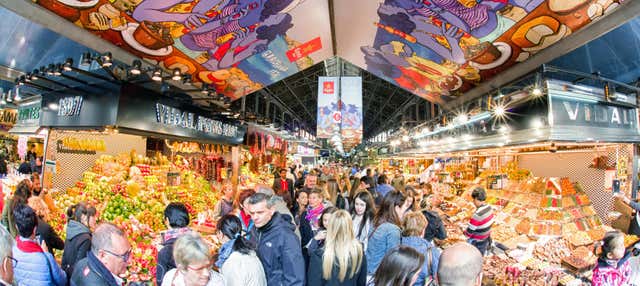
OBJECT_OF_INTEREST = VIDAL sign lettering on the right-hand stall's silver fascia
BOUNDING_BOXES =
[552,98,637,128]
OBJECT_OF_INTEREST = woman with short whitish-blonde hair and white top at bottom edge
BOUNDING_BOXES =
[162,232,226,286]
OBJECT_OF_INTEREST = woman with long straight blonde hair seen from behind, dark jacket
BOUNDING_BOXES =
[307,210,367,286]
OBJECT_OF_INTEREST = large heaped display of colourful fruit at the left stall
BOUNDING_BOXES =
[50,152,220,283]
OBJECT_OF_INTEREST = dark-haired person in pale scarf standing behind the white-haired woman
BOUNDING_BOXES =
[156,202,191,285]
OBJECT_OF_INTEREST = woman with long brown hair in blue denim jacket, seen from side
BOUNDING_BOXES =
[366,191,411,274]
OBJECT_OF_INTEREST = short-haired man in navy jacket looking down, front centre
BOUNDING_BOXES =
[248,193,305,286]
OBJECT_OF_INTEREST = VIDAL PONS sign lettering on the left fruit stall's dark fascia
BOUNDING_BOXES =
[156,103,238,138]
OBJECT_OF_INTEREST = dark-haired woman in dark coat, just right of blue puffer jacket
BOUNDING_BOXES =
[62,202,96,277]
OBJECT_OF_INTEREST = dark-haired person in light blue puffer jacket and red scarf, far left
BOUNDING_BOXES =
[12,204,67,286]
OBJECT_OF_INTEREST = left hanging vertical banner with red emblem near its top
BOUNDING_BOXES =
[316,77,342,138]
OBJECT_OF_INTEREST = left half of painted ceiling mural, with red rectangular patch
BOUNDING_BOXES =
[34,0,333,99]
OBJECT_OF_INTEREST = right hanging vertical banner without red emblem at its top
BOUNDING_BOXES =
[340,77,362,149]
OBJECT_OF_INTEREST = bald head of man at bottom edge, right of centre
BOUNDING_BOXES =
[438,242,482,286]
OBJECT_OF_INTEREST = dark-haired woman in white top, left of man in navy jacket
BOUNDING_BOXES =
[216,215,267,286]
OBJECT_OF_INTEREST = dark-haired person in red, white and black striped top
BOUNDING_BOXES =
[464,187,495,255]
